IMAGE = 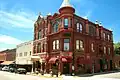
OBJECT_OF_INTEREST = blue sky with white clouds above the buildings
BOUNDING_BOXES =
[0,0,120,51]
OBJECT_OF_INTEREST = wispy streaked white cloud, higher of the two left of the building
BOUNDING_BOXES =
[0,10,37,28]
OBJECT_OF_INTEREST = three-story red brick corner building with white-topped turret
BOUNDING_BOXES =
[33,0,114,74]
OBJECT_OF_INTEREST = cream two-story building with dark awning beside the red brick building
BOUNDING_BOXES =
[16,41,33,71]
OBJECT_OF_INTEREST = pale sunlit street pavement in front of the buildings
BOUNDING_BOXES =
[0,71,120,80]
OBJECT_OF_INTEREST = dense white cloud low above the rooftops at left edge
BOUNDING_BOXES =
[0,34,22,45]
